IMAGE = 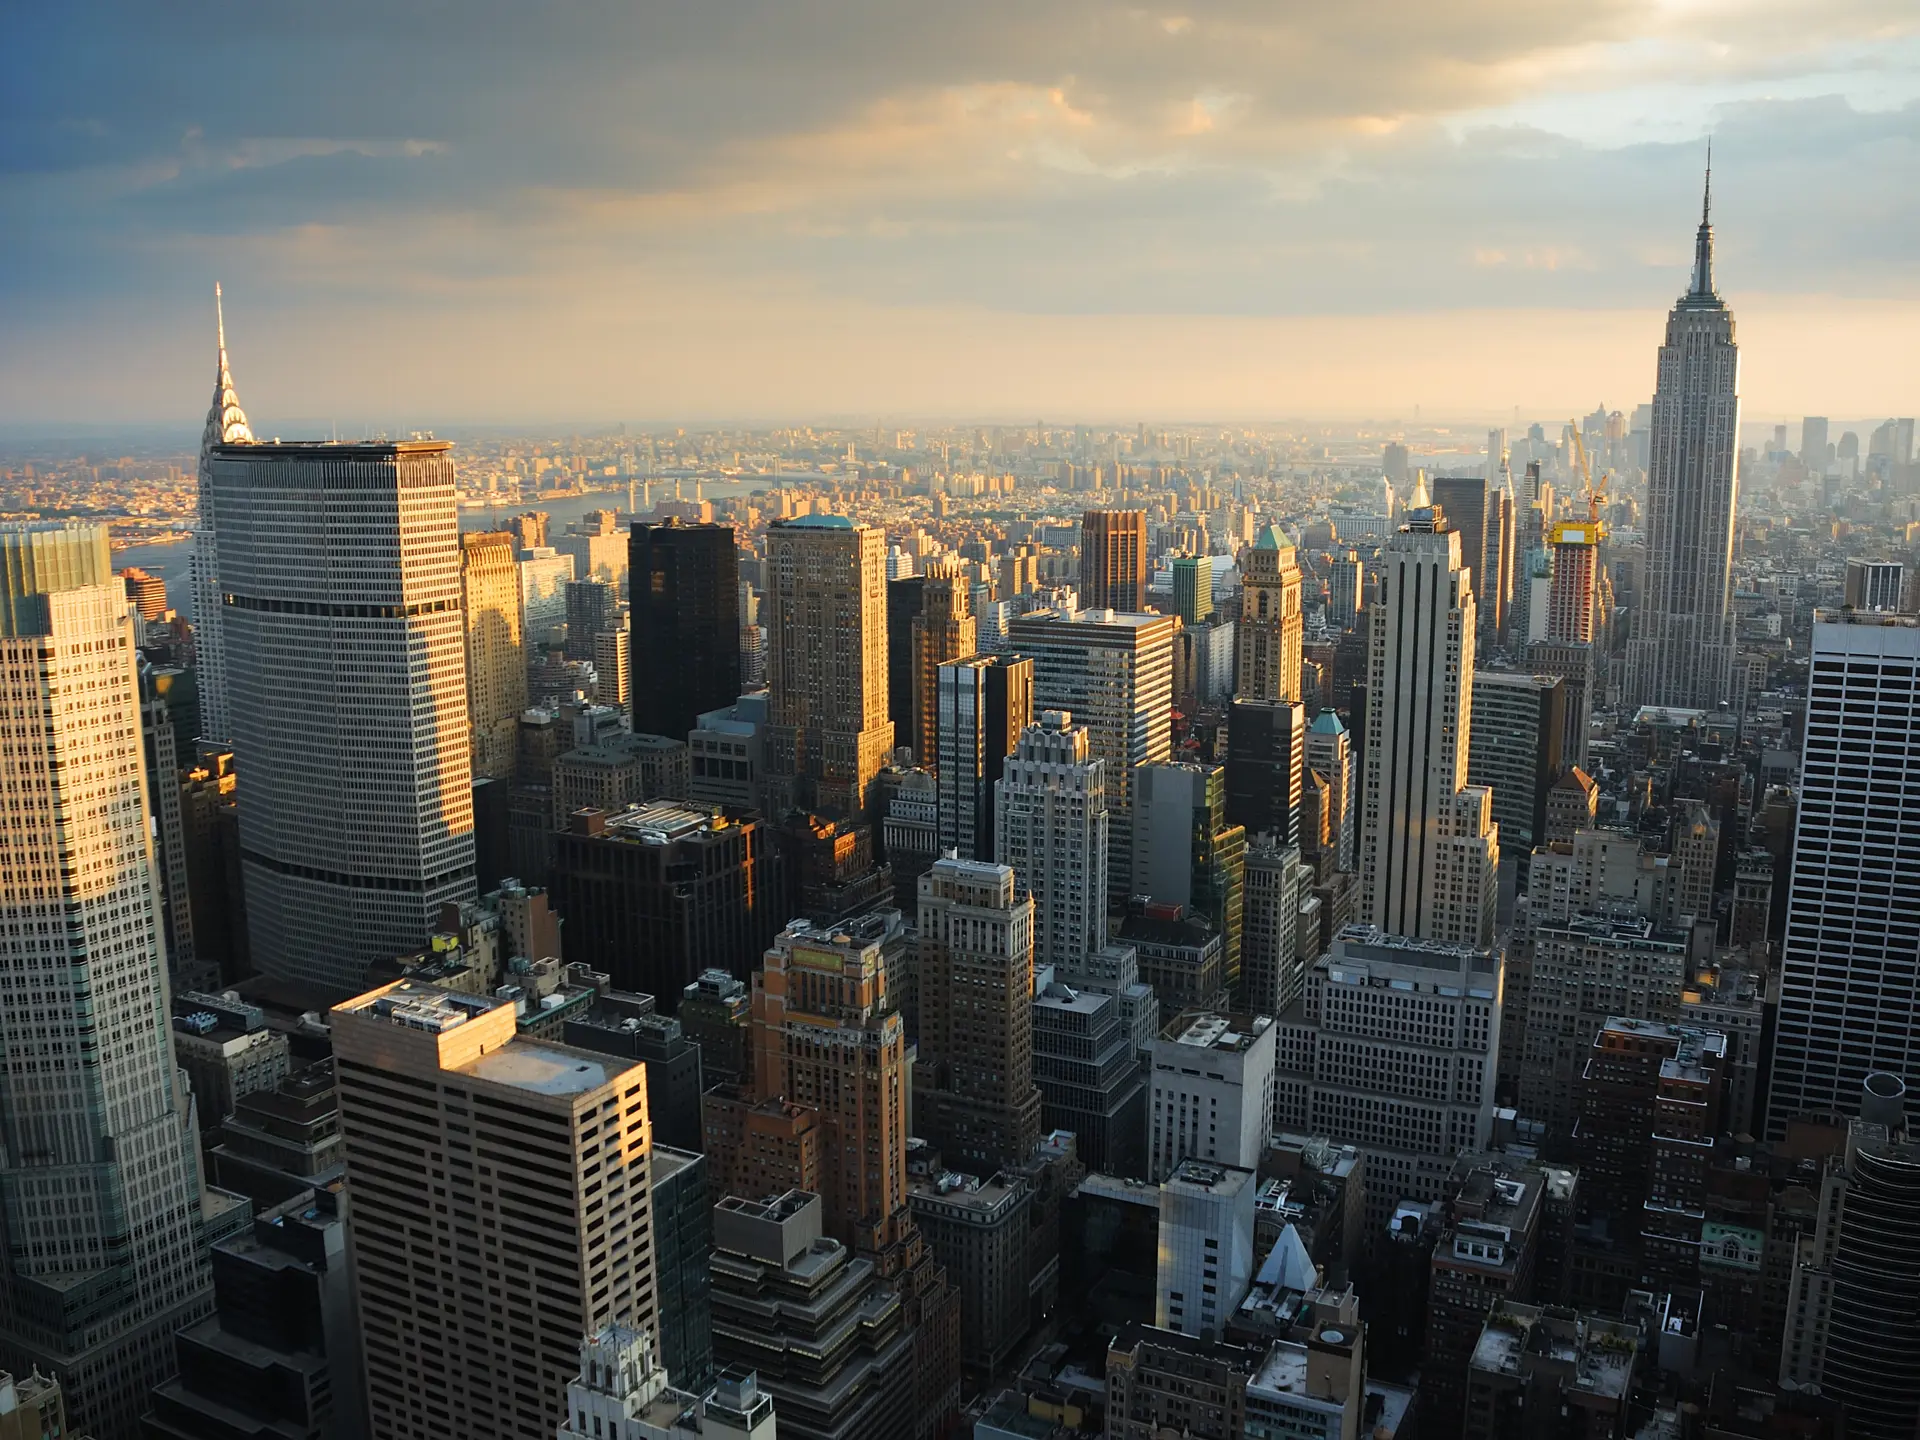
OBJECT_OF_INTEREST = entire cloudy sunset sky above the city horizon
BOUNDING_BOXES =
[0,0,1920,434]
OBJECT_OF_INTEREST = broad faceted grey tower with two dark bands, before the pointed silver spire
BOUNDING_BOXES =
[209,440,474,993]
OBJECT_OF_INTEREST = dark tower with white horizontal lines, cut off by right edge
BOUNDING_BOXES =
[1766,611,1920,1139]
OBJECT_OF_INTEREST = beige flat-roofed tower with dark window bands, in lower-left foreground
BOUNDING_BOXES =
[330,979,655,1440]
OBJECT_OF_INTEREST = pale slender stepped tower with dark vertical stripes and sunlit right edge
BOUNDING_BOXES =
[1359,486,1500,947]
